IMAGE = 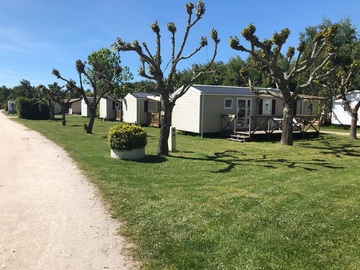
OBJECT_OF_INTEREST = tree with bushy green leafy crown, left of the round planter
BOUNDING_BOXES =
[52,48,132,133]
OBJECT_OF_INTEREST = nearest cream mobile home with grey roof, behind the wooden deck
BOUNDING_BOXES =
[172,85,315,135]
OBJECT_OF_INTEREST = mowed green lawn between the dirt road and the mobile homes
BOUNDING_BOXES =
[12,117,360,269]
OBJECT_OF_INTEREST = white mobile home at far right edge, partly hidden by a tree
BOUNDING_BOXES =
[331,90,360,126]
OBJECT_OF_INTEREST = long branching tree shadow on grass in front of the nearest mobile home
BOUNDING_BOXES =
[174,150,343,173]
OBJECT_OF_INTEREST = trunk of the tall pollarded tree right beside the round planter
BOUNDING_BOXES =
[158,101,174,156]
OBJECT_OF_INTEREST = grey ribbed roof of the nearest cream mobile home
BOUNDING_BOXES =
[193,84,275,96]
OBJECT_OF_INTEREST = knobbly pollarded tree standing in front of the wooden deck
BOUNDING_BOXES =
[229,24,336,145]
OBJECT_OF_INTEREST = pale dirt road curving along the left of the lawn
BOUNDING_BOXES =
[0,112,137,270]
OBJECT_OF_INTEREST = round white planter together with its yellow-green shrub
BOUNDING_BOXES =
[108,124,147,160]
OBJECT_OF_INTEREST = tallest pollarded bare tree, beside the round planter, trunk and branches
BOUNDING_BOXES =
[113,0,220,155]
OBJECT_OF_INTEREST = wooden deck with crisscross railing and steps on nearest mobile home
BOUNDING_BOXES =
[221,115,320,141]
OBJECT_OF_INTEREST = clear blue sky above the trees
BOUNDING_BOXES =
[0,0,360,88]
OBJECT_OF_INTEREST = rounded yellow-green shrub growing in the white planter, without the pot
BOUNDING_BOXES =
[108,124,147,151]
